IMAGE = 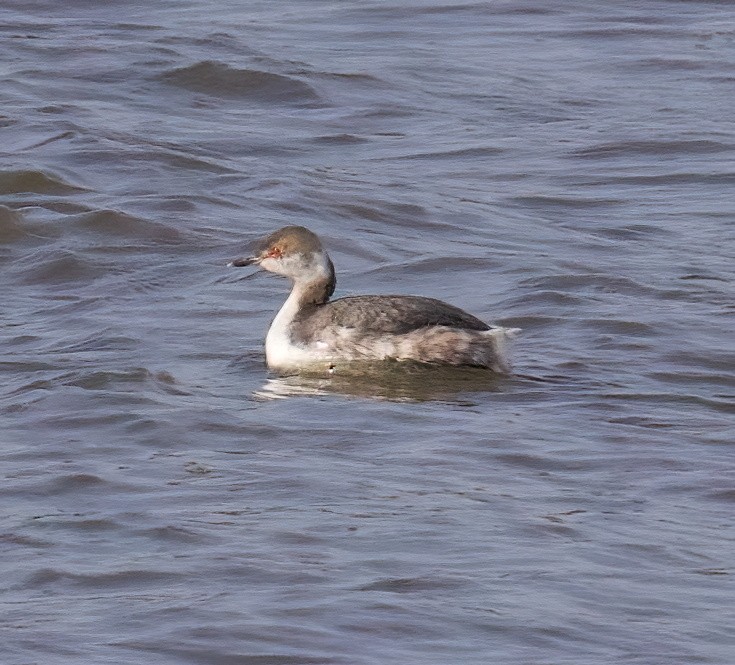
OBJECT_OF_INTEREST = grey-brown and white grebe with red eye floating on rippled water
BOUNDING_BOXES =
[229,226,516,374]
